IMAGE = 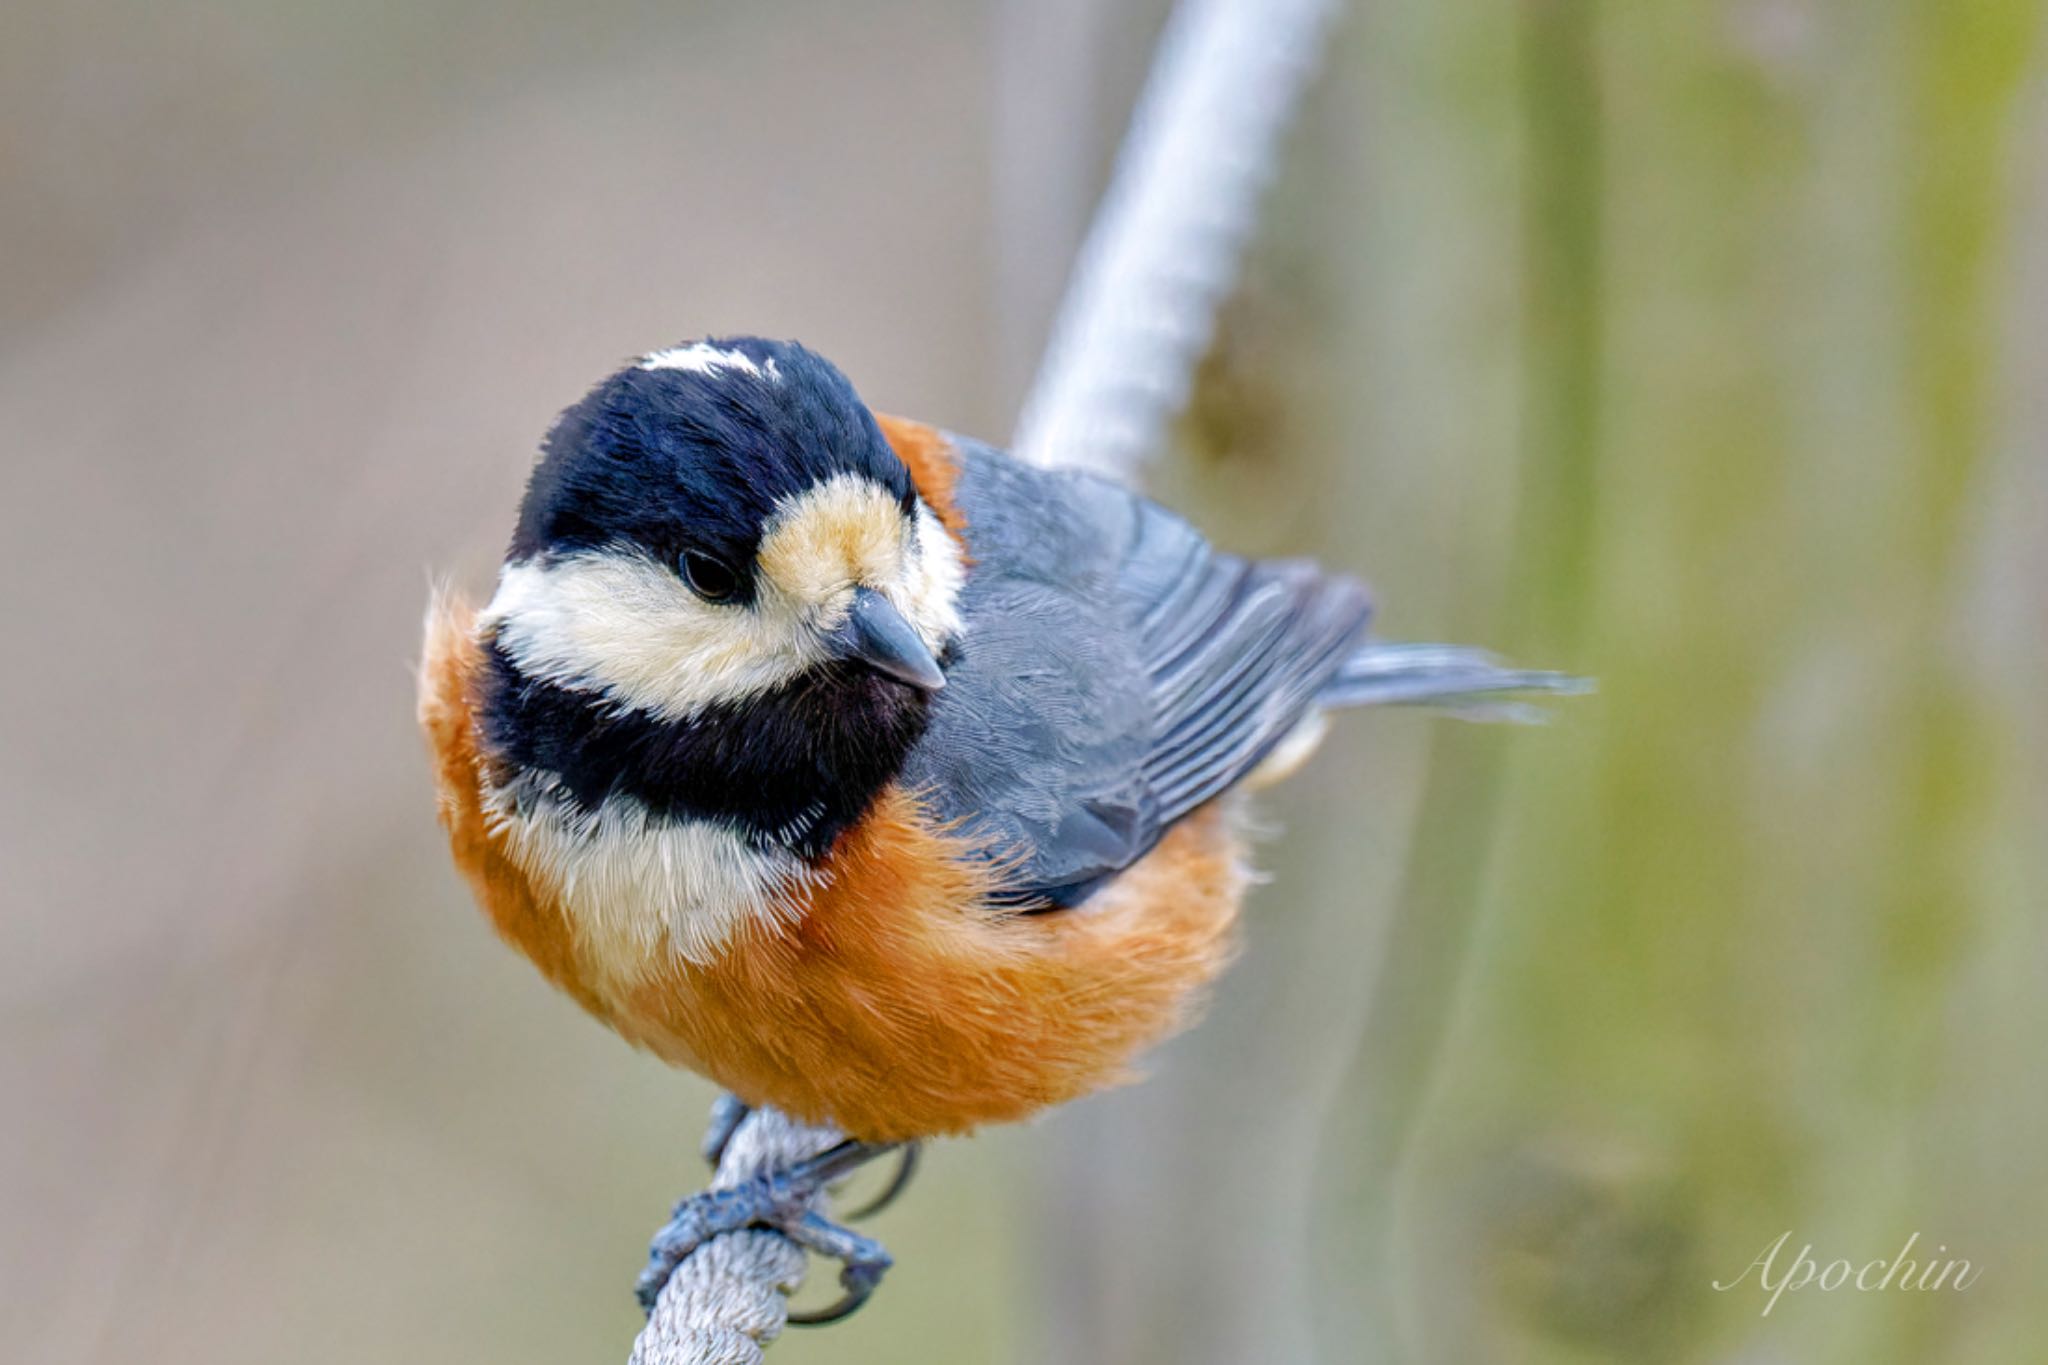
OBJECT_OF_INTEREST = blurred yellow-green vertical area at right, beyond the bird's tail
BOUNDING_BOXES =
[1327,0,2048,1363]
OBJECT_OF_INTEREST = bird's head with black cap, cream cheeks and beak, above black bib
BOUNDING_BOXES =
[483,338,963,720]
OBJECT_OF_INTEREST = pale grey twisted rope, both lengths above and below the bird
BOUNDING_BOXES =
[631,0,1339,1365]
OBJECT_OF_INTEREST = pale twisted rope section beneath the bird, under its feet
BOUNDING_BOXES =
[631,1109,840,1365]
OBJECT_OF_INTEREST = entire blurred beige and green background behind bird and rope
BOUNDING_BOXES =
[0,0,2048,1365]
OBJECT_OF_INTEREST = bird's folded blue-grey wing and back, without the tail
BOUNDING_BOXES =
[905,442,1370,905]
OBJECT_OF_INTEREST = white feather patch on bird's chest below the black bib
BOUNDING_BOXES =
[485,772,817,970]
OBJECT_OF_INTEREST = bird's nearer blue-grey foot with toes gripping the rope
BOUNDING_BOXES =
[635,1140,895,1326]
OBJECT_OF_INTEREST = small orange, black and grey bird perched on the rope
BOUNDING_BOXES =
[420,338,1575,1320]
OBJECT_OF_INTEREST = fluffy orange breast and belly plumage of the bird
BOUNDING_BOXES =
[420,604,1247,1140]
